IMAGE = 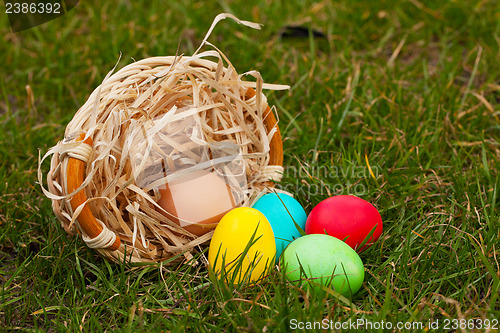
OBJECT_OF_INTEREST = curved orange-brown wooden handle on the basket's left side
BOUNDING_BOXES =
[66,134,121,251]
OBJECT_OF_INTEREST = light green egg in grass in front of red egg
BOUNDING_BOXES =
[281,234,365,296]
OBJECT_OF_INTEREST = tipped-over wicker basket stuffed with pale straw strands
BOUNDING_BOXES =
[38,14,286,263]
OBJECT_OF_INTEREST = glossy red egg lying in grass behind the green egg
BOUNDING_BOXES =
[305,195,382,252]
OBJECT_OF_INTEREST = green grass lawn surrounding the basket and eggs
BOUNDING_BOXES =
[0,0,500,332]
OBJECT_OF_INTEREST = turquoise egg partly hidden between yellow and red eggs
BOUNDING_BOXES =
[252,193,307,262]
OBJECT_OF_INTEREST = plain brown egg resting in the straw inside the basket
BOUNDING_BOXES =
[158,170,235,236]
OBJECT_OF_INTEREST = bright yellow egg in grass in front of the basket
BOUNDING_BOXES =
[208,207,276,283]
